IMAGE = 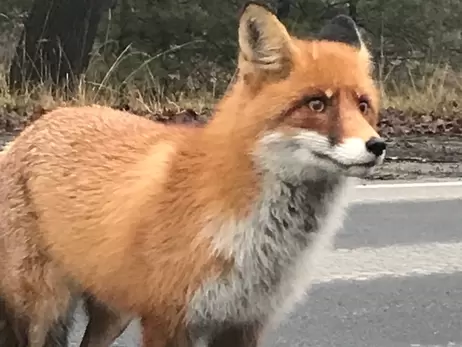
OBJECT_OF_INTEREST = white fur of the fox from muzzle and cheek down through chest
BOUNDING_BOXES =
[186,131,383,340]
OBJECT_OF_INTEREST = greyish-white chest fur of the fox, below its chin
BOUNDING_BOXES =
[187,177,347,330]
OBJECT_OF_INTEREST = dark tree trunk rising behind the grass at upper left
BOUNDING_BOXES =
[9,0,114,90]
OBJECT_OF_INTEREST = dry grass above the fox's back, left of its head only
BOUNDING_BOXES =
[0,34,226,117]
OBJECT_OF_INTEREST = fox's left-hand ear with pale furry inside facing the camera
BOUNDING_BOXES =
[239,2,292,76]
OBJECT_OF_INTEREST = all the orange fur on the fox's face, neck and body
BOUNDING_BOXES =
[0,3,379,347]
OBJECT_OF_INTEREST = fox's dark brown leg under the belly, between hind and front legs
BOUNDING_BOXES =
[80,294,133,347]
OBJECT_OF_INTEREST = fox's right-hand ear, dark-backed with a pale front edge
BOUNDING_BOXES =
[318,14,370,67]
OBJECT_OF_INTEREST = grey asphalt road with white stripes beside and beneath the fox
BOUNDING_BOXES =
[67,182,462,347]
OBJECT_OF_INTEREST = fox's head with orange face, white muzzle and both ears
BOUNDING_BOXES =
[218,2,386,179]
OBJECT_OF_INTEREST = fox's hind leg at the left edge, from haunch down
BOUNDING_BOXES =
[0,177,77,347]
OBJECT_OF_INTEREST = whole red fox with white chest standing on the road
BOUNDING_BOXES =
[0,2,386,347]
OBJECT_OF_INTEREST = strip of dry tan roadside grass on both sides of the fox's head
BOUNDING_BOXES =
[0,49,462,117]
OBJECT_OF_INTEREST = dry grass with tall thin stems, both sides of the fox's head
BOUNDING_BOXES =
[0,2,462,121]
